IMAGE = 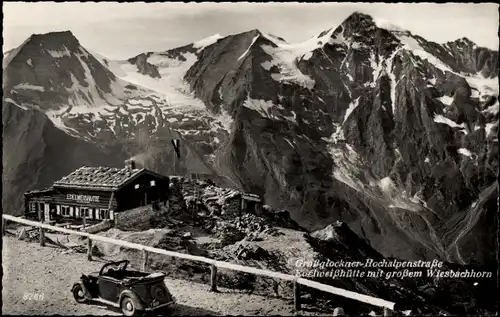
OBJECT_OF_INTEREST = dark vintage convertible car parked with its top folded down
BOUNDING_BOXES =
[71,260,175,316]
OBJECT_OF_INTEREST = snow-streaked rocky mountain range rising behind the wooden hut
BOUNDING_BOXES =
[3,13,498,263]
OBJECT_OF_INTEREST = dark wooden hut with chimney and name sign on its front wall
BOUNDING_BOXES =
[24,161,169,221]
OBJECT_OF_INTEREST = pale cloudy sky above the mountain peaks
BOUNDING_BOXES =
[3,2,499,59]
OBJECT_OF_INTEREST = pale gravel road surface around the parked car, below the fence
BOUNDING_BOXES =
[2,235,330,316]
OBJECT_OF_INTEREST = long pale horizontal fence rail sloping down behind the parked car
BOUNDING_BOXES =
[2,215,395,310]
